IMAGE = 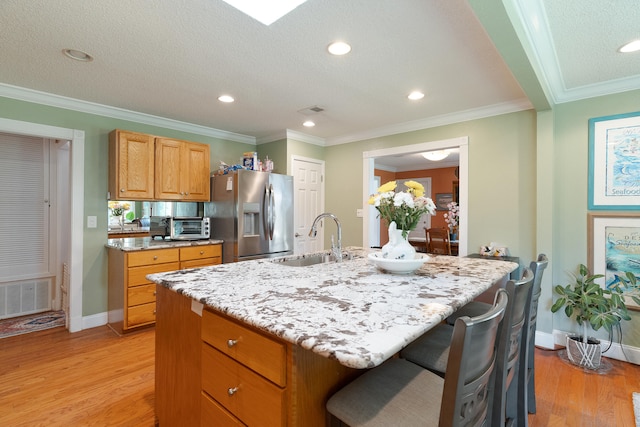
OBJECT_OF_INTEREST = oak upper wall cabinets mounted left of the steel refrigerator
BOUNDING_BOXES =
[109,129,210,202]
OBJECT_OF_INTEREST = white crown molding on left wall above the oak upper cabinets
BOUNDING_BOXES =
[0,83,256,145]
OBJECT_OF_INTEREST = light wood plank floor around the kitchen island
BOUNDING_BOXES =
[0,326,640,427]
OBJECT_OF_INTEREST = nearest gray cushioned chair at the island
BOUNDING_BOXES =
[327,289,509,427]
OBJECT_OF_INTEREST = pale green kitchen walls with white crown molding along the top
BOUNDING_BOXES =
[0,91,640,354]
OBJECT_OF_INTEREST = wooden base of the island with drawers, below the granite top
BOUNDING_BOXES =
[155,285,365,427]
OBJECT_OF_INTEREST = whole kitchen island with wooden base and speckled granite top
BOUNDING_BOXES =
[148,248,518,426]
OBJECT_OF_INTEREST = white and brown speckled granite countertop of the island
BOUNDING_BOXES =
[147,248,518,369]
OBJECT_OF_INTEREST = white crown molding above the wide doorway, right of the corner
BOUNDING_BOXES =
[326,98,533,146]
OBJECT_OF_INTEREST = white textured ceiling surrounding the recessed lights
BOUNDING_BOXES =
[0,0,640,158]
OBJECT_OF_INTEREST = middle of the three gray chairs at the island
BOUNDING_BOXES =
[400,268,534,426]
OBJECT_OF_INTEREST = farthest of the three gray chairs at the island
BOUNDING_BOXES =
[447,254,549,426]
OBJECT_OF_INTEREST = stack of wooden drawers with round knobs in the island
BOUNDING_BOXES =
[201,310,287,426]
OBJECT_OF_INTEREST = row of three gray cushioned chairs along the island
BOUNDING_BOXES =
[327,256,549,427]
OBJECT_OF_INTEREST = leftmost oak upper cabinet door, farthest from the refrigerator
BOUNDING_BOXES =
[109,130,155,200]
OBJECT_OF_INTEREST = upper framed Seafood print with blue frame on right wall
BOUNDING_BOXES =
[588,112,640,210]
